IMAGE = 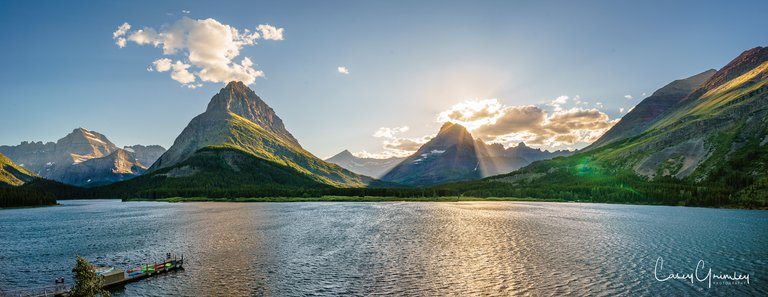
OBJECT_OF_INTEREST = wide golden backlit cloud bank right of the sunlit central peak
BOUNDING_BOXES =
[437,96,618,148]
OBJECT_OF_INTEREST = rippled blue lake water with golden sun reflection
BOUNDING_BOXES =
[0,200,768,296]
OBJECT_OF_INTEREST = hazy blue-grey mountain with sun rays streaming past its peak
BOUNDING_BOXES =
[381,122,568,186]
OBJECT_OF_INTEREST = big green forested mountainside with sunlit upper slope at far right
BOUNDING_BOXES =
[446,47,768,208]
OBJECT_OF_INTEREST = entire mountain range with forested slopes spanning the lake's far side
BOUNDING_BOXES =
[0,47,768,207]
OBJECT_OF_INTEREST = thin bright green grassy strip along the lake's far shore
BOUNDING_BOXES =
[123,196,565,203]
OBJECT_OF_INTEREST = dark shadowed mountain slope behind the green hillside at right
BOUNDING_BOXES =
[585,69,717,150]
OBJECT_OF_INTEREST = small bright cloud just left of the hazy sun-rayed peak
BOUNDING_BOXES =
[354,126,434,159]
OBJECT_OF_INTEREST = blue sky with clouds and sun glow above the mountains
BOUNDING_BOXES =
[0,1,768,158]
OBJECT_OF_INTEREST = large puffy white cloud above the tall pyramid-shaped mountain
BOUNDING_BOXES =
[112,17,283,88]
